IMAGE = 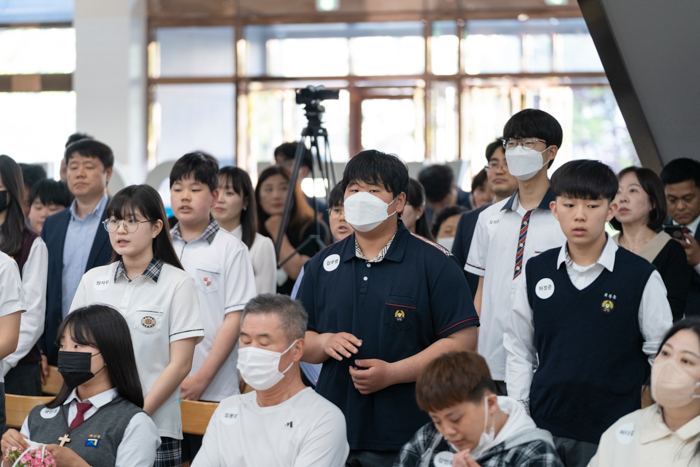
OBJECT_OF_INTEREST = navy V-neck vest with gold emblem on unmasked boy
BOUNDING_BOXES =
[525,248,655,443]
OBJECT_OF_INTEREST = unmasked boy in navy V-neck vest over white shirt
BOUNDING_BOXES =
[504,160,672,467]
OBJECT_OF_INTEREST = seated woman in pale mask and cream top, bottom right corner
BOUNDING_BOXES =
[588,318,700,467]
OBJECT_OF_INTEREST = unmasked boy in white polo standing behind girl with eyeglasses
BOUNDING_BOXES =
[170,152,256,460]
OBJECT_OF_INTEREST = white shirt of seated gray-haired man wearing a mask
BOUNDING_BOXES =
[192,388,350,467]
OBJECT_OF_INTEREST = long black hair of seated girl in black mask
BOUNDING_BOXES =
[46,305,143,409]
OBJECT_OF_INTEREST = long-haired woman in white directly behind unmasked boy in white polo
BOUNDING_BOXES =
[211,166,277,294]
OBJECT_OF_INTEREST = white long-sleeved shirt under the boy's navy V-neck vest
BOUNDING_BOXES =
[503,235,673,402]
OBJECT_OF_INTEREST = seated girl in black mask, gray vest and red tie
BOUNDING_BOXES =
[2,305,160,467]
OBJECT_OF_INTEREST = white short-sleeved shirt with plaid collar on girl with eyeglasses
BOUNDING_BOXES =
[70,258,204,439]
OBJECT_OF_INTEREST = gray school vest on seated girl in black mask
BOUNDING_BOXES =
[27,396,143,467]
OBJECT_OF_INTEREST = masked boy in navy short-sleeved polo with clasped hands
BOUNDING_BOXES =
[297,150,479,467]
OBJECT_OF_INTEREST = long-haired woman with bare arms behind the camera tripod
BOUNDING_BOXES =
[255,165,328,295]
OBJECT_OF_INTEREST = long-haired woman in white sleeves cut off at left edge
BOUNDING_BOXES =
[0,155,49,396]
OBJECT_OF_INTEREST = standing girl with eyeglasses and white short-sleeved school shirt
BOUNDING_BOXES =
[71,185,204,467]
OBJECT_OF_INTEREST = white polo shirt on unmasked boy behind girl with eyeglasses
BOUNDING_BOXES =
[170,220,255,402]
